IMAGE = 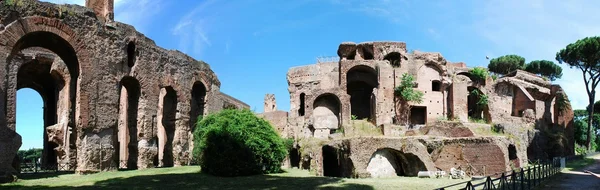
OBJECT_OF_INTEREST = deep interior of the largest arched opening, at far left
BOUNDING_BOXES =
[6,31,79,170]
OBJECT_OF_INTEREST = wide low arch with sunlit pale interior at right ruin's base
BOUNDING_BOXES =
[367,148,427,178]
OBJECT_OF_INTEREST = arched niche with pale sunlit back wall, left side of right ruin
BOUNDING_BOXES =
[312,93,342,136]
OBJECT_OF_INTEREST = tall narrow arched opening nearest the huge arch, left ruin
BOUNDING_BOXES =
[115,76,141,169]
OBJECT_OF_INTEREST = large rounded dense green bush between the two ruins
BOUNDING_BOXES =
[193,109,288,176]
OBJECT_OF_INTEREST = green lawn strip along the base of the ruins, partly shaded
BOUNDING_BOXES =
[0,166,478,189]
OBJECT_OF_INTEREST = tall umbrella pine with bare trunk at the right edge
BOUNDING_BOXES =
[556,36,600,150]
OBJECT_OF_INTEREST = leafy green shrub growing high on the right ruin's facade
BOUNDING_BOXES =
[394,73,423,124]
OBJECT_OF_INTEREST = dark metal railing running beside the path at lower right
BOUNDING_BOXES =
[438,159,561,190]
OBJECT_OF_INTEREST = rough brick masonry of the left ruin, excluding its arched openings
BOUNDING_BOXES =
[0,1,246,173]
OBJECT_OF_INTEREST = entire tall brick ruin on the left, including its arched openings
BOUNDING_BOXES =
[0,0,249,176]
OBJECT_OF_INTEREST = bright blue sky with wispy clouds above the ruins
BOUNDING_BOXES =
[17,0,600,148]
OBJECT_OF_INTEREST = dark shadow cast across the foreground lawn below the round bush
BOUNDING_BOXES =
[7,173,374,190]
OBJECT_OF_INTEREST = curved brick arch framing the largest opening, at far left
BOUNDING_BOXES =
[0,16,91,172]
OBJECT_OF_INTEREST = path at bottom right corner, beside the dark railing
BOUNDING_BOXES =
[540,154,600,189]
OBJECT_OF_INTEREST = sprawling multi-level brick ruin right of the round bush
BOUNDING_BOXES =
[261,42,574,177]
